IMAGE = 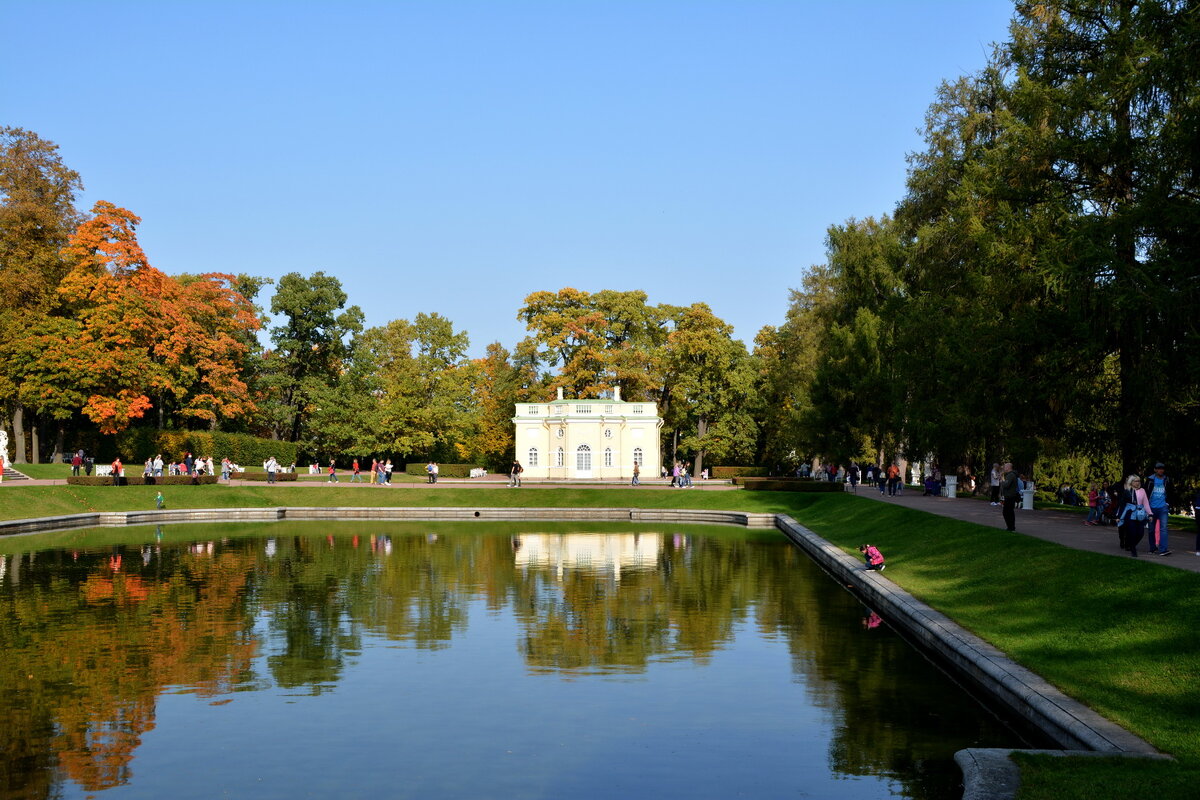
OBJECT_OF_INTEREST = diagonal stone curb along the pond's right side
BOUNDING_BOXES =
[776,515,1158,756]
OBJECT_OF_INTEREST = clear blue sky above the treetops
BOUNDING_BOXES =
[0,0,1012,355]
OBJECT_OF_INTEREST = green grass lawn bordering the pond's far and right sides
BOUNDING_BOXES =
[0,485,1200,800]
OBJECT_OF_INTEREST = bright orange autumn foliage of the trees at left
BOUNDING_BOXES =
[49,201,259,433]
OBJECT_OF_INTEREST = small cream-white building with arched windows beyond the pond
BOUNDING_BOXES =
[512,389,662,480]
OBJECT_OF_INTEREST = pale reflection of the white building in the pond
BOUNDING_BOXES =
[514,534,662,581]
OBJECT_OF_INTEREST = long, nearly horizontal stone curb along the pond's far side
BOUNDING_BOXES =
[0,506,775,536]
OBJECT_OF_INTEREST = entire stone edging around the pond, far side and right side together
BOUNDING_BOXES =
[0,506,1163,800]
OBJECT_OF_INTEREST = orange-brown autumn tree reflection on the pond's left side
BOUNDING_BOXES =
[0,552,261,799]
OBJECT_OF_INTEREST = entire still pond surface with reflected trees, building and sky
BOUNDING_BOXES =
[0,523,1021,800]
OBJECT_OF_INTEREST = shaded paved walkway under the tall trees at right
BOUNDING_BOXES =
[858,486,1200,572]
